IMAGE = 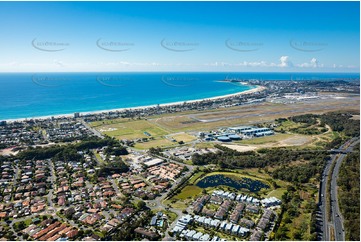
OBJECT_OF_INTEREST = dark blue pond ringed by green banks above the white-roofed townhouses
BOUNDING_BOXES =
[196,174,269,192]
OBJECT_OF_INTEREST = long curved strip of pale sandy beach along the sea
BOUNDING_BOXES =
[0,85,266,122]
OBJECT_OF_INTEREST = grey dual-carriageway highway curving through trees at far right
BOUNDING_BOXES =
[319,138,360,241]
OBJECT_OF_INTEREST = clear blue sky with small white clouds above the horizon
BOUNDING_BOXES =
[0,2,360,72]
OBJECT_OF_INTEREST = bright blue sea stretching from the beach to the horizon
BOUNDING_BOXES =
[0,72,359,120]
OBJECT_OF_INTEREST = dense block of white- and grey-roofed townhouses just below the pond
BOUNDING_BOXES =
[172,190,281,241]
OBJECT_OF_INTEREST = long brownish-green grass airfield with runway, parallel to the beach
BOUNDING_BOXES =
[151,95,359,132]
